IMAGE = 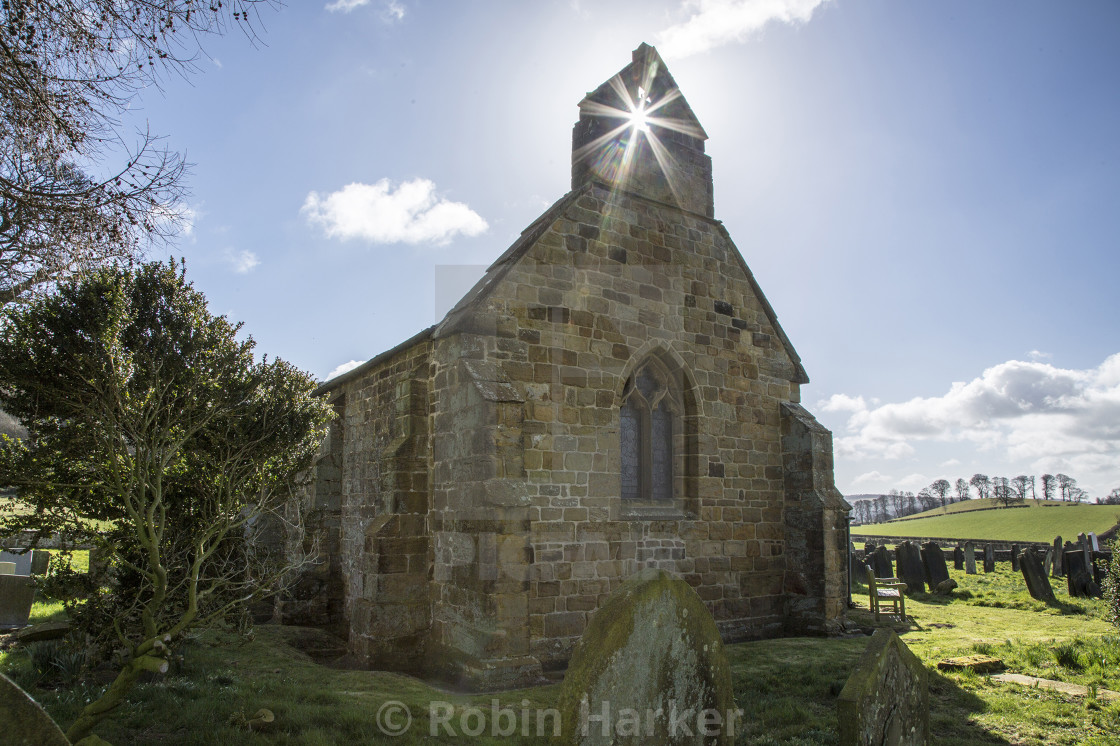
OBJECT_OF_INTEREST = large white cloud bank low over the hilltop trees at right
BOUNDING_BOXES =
[818,354,1120,494]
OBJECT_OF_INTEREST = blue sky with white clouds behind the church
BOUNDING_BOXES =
[127,0,1120,496]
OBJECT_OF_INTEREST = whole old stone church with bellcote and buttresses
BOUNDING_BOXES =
[281,45,849,688]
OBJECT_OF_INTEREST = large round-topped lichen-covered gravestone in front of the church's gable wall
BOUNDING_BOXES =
[559,568,743,745]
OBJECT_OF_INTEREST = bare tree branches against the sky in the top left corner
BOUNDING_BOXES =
[0,0,271,305]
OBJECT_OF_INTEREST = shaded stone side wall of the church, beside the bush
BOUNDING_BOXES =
[329,341,431,670]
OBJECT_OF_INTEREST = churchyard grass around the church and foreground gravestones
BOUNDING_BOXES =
[0,563,1120,746]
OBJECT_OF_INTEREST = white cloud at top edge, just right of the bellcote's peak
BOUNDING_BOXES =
[656,0,828,58]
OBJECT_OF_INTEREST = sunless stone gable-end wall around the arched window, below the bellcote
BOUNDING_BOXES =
[432,181,815,681]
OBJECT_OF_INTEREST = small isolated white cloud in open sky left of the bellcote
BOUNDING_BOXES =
[301,179,489,244]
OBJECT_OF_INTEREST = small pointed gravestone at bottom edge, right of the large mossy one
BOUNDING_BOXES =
[837,628,930,746]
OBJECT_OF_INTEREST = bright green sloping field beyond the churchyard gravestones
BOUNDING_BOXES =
[851,500,1120,542]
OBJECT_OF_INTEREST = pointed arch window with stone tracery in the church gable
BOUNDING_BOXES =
[619,358,681,502]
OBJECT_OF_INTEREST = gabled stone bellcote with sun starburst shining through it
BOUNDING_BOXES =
[571,44,715,217]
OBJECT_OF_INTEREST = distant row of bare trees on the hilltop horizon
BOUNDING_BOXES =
[851,474,1102,524]
